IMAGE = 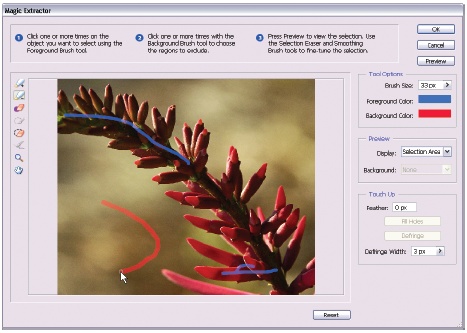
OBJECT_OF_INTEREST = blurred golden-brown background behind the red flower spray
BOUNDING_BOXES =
[58,79,319,295]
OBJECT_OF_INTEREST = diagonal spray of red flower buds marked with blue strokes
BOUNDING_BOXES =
[58,85,315,295]
